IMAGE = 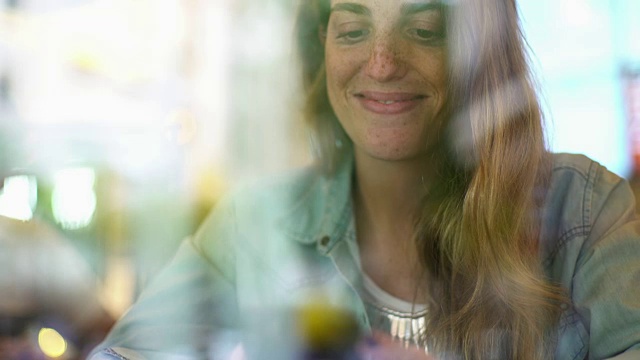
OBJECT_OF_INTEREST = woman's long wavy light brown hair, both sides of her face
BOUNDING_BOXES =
[296,0,565,359]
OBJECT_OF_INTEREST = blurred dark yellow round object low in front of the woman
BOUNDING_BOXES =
[296,302,359,351]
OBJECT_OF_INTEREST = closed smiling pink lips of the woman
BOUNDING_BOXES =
[354,91,425,115]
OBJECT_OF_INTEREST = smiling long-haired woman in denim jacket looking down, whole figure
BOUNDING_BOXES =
[89,0,640,360]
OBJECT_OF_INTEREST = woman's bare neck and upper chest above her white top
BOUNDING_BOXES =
[353,152,432,301]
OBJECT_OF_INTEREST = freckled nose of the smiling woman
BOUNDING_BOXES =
[365,37,407,82]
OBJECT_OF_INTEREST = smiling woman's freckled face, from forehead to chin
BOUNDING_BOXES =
[325,0,447,161]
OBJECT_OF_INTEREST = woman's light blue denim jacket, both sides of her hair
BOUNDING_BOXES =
[91,154,640,360]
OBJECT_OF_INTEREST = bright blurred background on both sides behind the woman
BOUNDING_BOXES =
[0,0,640,359]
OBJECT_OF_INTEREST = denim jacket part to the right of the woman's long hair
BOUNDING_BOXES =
[541,159,640,359]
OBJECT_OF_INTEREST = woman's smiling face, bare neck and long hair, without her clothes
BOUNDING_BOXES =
[298,1,563,359]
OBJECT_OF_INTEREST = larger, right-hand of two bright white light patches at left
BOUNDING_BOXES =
[51,168,96,230]
